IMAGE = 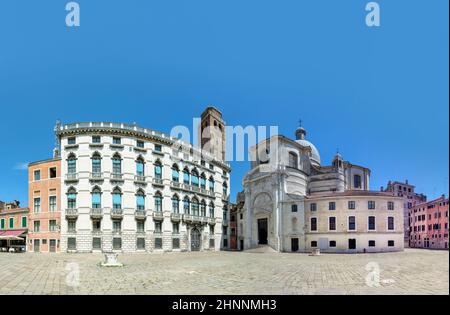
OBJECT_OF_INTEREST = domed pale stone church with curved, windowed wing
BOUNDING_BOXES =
[243,127,404,253]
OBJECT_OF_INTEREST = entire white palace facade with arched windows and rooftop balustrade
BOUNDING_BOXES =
[56,107,231,252]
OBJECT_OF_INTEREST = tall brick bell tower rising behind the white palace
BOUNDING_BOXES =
[199,106,226,161]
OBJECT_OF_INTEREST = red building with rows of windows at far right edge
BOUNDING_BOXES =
[409,195,448,249]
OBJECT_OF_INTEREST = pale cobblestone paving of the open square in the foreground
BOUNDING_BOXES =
[0,249,449,295]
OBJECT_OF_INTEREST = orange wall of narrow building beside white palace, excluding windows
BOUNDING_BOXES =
[28,159,61,252]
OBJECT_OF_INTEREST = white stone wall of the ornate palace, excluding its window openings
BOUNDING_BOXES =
[56,128,230,252]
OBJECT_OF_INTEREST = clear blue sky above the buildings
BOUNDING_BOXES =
[0,0,449,202]
